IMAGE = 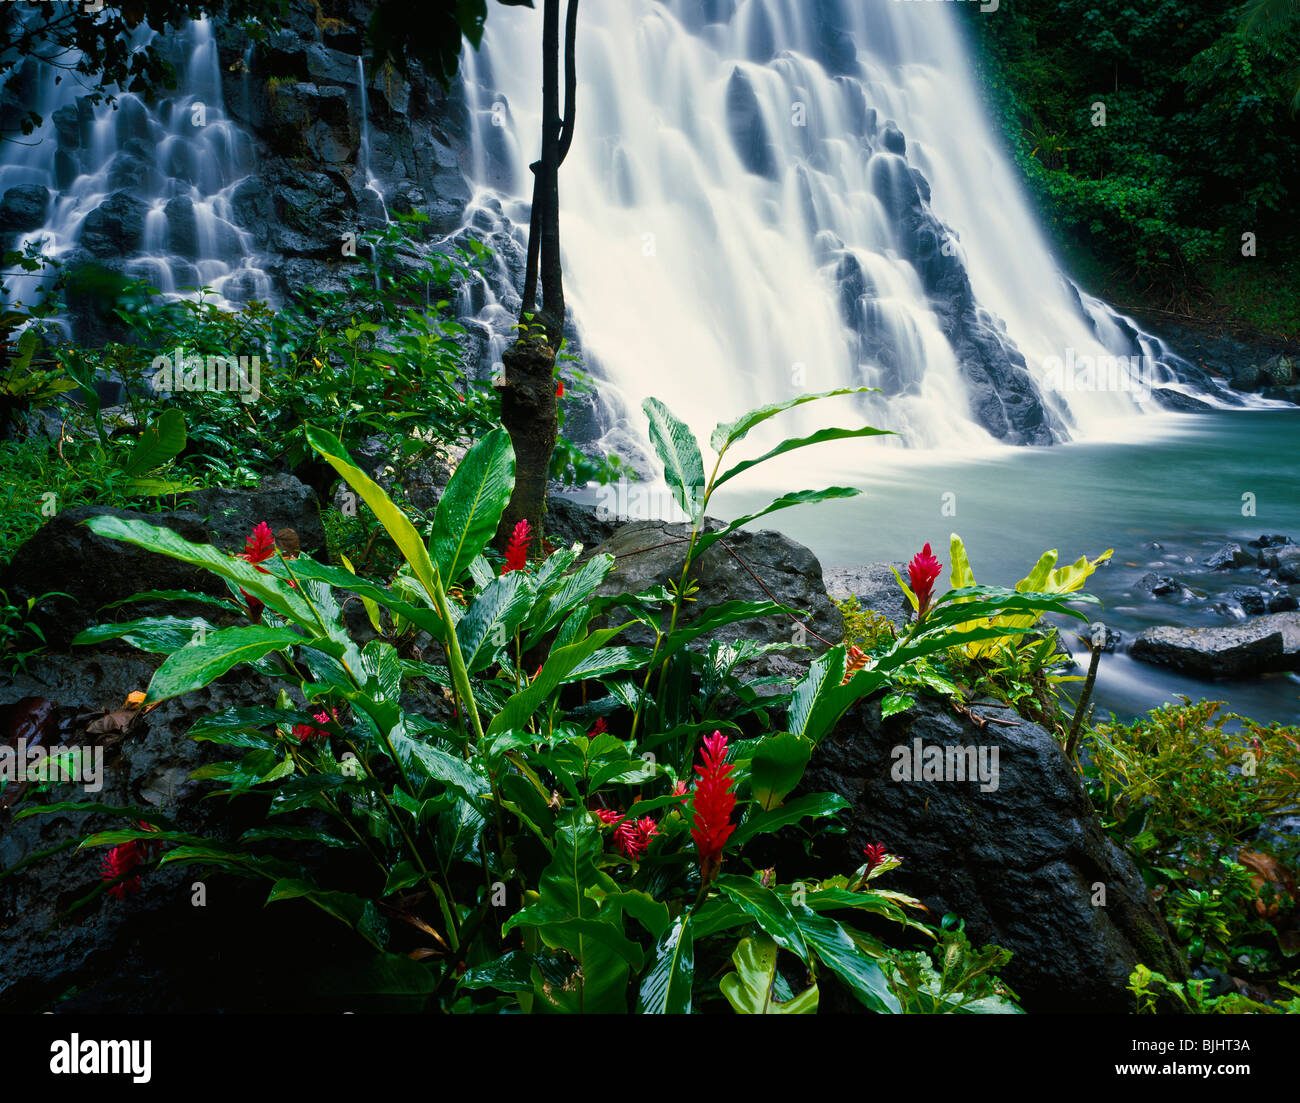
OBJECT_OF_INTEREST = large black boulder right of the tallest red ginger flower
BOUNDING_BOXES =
[792,697,1187,1013]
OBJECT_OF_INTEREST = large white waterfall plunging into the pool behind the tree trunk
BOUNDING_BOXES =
[463,0,1227,457]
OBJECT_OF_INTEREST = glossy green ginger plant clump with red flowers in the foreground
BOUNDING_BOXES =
[20,392,1092,1013]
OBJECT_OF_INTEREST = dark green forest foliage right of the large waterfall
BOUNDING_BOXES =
[970,0,1300,333]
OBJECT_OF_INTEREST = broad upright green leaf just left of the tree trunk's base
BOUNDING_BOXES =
[432,429,515,587]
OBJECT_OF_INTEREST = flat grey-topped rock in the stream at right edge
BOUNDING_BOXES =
[1128,613,1300,678]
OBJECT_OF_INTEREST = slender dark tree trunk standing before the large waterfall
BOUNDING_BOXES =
[497,0,577,554]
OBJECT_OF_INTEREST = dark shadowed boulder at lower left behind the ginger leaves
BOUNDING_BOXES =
[0,654,354,1013]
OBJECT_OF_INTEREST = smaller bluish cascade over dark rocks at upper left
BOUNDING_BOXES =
[0,20,272,322]
